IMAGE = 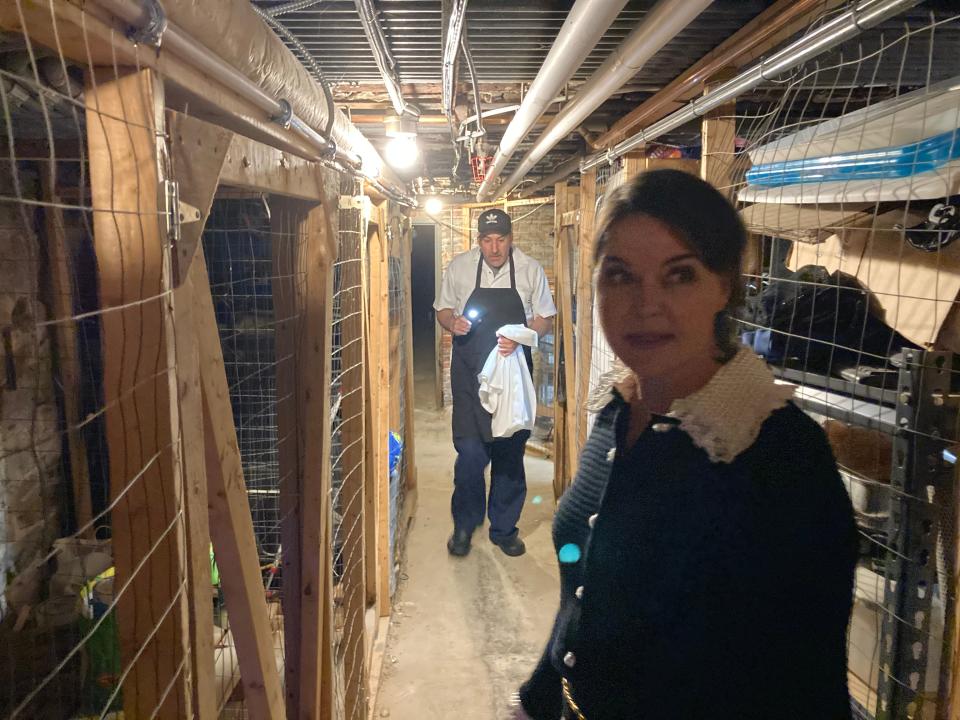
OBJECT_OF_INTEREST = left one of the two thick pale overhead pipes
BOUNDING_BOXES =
[477,0,629,202]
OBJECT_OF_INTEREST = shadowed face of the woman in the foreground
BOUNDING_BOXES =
[597,215,730,378]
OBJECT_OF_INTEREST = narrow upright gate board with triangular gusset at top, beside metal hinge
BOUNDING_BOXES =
[167,113,232,718]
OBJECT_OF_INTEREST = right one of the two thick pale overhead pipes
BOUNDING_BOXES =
[496,0,711,199]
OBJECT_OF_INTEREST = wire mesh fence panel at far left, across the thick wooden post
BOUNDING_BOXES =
[0,19,189,718]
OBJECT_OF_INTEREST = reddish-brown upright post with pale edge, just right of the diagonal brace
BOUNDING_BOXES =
[287,193,339,720]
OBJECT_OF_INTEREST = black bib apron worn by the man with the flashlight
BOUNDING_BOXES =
[450,250,533,442]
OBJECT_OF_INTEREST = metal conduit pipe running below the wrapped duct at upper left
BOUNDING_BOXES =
[96,0,416,206]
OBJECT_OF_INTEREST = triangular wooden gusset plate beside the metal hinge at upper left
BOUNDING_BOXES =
[167,112,232,285]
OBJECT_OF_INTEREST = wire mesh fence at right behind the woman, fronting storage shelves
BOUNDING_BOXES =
[728,11,960,718]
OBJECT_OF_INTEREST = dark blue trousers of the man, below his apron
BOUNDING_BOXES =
[450,431,530,542]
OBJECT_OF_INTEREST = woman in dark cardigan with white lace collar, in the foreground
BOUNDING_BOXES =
[513,170,857,720]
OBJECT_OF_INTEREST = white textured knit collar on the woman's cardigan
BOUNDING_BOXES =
[588,347,795,463]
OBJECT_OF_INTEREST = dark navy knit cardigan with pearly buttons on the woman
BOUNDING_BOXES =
[520,397,858,720]
